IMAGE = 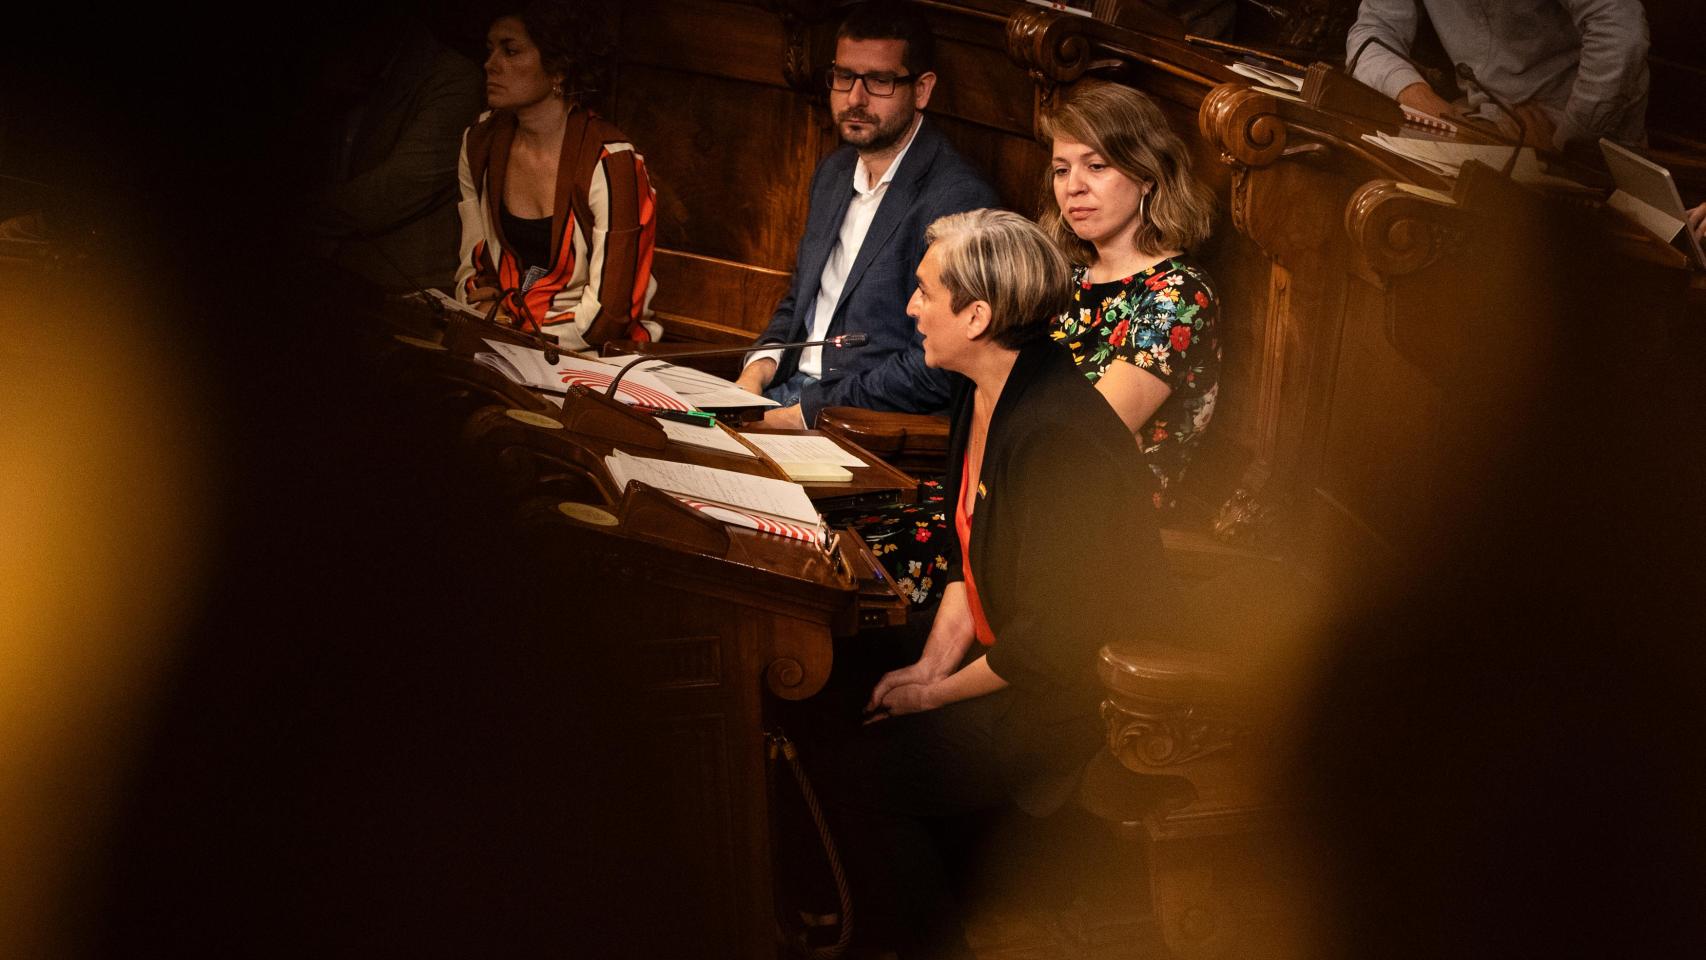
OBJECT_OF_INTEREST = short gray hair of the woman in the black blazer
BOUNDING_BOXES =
[925,210,1071,350]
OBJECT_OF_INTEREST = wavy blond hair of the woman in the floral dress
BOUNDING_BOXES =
[1037,80,1215,266]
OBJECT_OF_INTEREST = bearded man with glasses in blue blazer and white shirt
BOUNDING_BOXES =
[739,0,998,428]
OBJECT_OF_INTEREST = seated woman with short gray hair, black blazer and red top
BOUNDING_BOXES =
[817,210,1163,957]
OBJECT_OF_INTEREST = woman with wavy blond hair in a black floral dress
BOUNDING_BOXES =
[1041,84,1220,510]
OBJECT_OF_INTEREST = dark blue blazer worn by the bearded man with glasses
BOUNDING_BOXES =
[757,119,1000,425]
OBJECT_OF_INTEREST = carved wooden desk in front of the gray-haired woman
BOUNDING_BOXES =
[379,298,916,960]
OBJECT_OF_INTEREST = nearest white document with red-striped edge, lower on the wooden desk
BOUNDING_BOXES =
[604,450,829,546]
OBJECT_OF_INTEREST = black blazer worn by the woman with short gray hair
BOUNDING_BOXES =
[945,339,1170,803]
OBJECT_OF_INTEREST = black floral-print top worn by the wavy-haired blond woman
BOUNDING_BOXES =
[1049,256,1220,510]
